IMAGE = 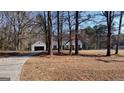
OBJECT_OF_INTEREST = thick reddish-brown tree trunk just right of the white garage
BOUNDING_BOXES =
[48,11,52,55]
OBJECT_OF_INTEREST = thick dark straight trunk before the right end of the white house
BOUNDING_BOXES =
[75,11,79,55]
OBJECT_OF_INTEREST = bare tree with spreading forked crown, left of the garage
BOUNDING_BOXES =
[4,11,33,50]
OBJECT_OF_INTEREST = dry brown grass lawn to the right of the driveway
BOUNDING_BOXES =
[21,50,124,81]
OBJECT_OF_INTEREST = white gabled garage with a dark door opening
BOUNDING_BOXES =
[31,41,46,51]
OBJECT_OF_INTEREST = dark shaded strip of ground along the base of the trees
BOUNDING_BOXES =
[0,51,124,58]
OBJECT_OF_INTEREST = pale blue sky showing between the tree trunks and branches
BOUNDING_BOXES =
[1,11,124,34]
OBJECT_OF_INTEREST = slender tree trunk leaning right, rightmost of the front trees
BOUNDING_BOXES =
[115,11,123,54]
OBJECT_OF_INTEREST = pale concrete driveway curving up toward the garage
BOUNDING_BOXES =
[0,52,38,81]
